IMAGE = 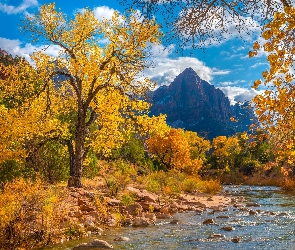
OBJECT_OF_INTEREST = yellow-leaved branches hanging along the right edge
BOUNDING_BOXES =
[249,7,295,163]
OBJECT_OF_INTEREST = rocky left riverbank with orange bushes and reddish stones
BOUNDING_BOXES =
[0,174,230,249]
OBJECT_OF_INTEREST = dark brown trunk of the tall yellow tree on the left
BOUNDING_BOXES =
[68,111,87,187]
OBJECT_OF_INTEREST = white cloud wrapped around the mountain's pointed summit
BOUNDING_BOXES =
[144,45,230,85]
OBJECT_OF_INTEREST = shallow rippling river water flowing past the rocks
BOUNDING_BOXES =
[43,186,295,250]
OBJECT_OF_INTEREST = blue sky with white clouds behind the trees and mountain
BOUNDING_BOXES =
[0,0,276,103]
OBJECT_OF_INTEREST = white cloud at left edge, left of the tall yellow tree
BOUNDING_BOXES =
[0,37,60,63]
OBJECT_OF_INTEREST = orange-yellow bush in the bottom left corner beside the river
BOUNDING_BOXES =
[0,179,65,249]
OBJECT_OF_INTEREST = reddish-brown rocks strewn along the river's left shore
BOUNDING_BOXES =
[61,185,232,250]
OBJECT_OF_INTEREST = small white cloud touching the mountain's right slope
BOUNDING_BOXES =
[218,86,263,105]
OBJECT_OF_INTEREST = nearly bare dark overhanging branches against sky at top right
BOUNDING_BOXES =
[122,0,292,48]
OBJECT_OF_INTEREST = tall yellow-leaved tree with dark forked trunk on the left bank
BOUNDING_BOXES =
[1,4,161,187]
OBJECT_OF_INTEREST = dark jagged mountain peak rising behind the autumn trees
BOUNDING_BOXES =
[150,68,254,139]
